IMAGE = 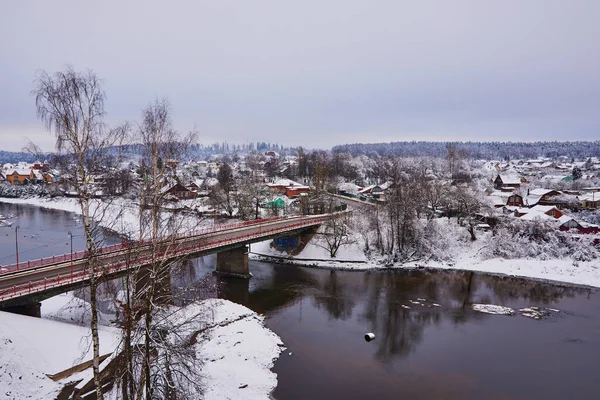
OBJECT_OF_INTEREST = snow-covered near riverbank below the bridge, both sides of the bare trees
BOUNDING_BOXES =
[0,294,284,400]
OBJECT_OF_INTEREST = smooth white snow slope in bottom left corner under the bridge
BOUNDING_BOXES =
[0,312,119,399]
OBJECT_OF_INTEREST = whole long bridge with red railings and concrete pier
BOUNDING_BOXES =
[0,214,330,314]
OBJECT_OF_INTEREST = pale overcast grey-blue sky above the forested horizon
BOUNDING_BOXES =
[0,0,600,150]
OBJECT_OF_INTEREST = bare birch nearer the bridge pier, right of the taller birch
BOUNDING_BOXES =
[115,99,199,400]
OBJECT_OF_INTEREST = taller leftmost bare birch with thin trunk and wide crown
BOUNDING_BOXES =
[32,66,123,399]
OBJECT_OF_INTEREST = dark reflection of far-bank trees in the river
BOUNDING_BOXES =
[164,262,590,363]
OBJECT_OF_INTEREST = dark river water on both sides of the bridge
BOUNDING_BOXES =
[0,204,600,400]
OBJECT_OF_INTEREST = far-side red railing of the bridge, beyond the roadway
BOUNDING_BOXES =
[0,217,326,275]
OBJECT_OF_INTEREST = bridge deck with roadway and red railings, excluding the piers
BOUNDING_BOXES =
[0,215,329,305]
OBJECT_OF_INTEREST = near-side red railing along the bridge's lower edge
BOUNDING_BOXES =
[0,217,327,302]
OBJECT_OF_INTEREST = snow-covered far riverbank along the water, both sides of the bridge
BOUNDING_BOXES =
[0,197,600,287]
